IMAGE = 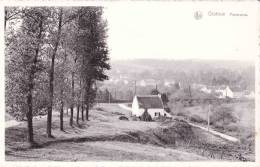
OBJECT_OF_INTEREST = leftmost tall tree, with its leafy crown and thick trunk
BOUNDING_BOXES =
[6,8,48,146]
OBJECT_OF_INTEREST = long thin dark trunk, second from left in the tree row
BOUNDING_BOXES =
[47,8,62,137]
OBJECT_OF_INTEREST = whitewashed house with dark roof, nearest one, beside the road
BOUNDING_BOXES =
[132,95,172,119]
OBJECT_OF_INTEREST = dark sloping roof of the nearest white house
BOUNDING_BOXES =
[137,95,163,109]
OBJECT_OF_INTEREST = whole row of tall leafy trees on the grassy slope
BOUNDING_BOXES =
[5,7,110,144]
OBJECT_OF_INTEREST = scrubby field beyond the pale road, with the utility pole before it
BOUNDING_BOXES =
[172,101,255,151]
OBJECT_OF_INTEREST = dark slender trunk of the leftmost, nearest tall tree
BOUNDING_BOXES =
[26,16,43,146]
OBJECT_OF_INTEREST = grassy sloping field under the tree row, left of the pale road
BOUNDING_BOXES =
[5,104,252,161]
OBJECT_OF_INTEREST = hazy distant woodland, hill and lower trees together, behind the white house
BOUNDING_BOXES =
[101,59,255,101]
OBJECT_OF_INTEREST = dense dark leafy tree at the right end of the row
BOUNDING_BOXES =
[76,7,110,120]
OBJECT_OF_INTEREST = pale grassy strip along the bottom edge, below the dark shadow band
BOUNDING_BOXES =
[6,141,207,161]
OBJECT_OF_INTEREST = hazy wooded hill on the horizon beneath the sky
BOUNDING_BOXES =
[108,59,255,90]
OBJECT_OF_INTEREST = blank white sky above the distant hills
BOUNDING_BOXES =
[104,2,259,60]
